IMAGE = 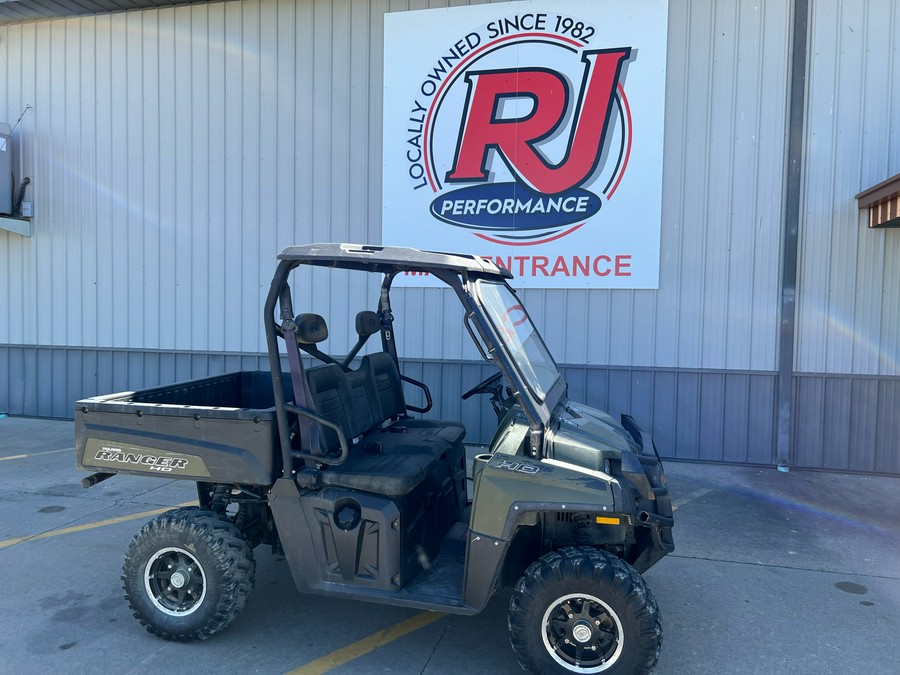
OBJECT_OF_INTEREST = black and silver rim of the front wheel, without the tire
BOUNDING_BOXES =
[541,593,624,673]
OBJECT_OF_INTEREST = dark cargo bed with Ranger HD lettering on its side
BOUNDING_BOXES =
[75,371,293,485]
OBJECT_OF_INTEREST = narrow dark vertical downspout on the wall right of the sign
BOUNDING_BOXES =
[775,0,809,471]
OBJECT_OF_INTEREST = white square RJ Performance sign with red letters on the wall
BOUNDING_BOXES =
[383,0,668,288]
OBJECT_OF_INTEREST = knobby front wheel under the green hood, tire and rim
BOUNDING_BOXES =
[509,547,662,675]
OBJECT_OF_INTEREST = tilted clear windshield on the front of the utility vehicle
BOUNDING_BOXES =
[477,280,560,402]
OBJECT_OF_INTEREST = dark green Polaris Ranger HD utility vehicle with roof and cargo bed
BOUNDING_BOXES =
[75,244,674,673]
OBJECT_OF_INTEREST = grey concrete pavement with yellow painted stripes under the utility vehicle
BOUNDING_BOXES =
[0,418,900,675]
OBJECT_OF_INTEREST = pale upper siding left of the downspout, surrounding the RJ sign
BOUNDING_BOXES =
[3,0,790,370]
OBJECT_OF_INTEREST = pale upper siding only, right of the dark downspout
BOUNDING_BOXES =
[796,0,900,376]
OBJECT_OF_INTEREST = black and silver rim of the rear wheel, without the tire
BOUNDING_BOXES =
[144,547,206,616]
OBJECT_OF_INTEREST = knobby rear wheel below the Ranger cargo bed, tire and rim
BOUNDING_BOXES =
[122,507,256,642]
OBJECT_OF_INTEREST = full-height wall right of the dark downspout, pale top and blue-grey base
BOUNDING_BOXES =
[793,0,900,473]
